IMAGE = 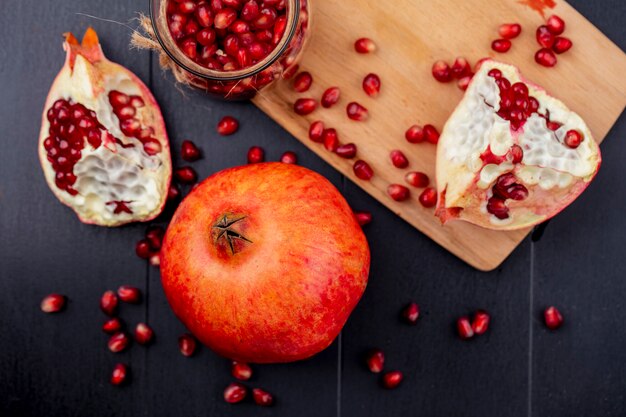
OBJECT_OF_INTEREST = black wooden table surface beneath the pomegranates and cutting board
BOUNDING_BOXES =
[0,0,626,417]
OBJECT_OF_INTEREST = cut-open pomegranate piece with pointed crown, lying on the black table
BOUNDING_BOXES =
[39,28,172,226]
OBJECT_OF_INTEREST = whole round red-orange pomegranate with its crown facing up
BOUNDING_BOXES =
[161,163,370,363]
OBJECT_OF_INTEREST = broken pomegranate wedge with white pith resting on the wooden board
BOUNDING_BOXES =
[436,60,601,230]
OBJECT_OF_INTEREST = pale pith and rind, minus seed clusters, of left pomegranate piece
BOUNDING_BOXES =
[39,32,171,226]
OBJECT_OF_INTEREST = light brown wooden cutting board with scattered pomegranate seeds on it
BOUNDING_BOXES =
[254,0,626,271]
